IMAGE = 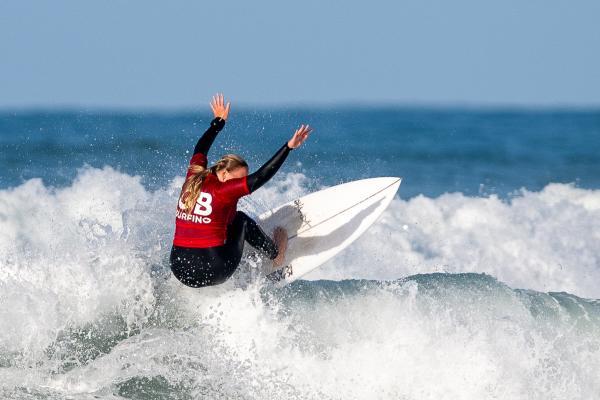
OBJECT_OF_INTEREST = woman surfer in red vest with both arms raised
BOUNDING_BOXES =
[170,94,312,287]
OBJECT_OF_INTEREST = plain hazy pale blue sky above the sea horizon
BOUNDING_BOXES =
[0,0,600,107]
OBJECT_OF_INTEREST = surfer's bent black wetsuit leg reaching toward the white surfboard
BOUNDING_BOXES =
[225,211,279,260]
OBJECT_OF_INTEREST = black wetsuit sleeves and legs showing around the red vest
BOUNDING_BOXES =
[170,118,291,287]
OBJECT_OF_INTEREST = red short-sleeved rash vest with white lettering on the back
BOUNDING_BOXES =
[173,153,250,248]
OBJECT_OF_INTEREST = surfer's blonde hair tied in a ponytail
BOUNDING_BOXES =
[180,154,248,212]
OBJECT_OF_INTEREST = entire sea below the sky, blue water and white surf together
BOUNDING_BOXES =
[0,107,600,400]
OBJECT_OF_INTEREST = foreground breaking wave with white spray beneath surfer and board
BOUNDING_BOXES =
[0,273,600,399]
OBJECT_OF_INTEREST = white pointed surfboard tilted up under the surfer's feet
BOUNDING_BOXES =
[259,177,402,286]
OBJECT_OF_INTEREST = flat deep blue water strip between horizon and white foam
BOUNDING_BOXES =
[0,108,600,198]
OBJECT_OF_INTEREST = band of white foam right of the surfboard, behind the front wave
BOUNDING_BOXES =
[309,184,600,298]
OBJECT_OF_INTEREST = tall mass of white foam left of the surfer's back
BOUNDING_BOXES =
[0,168,165,360]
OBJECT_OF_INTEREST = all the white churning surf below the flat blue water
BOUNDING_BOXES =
[0,168,600,399]
